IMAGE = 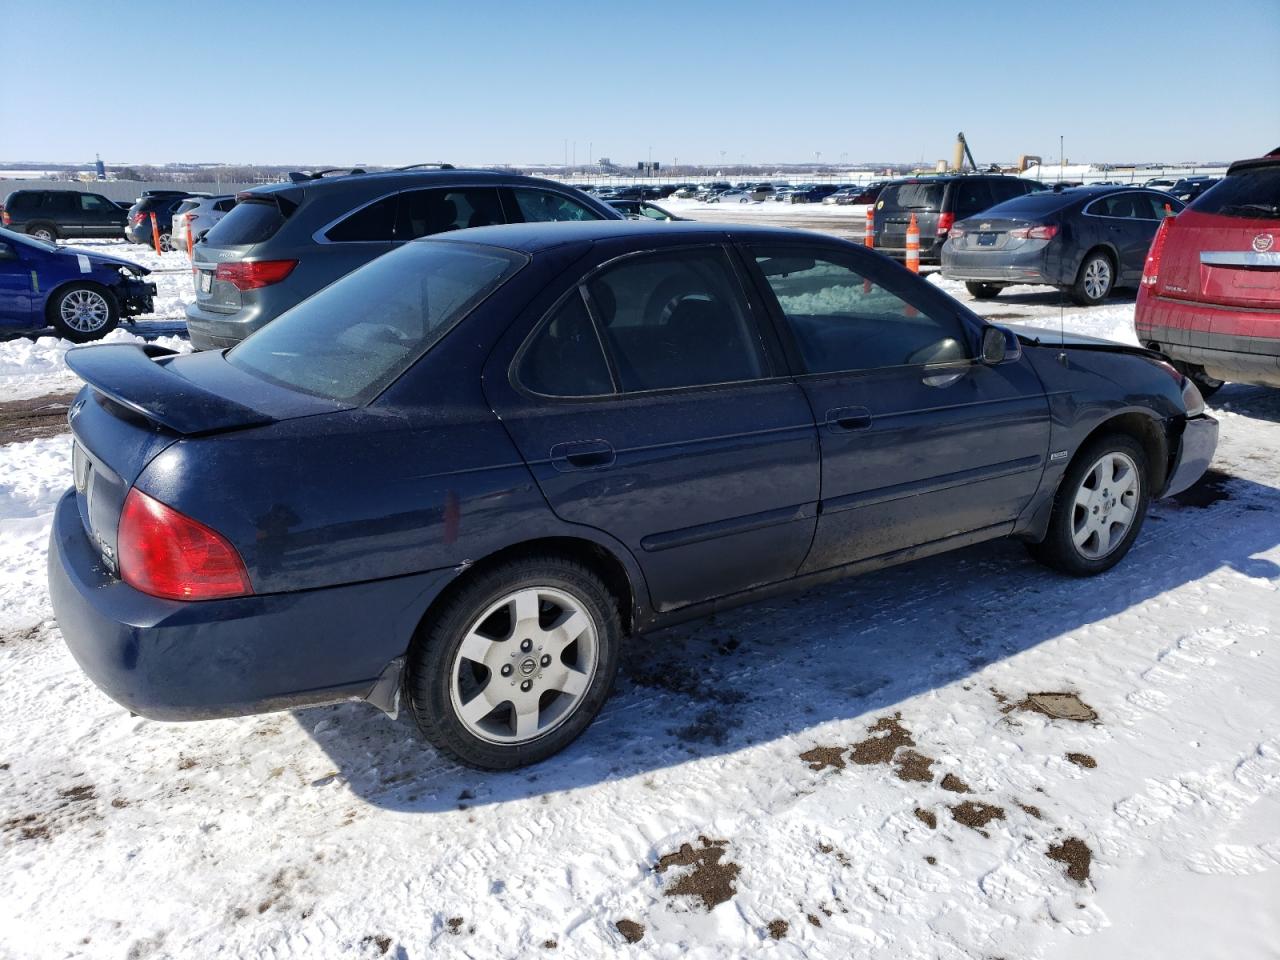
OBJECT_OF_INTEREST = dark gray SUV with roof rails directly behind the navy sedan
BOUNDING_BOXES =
[187,165,625,349]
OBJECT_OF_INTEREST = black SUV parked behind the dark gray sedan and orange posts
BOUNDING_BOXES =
[876,174,1044,264]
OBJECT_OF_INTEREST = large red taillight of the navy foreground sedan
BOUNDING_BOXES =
[116,486,253,600]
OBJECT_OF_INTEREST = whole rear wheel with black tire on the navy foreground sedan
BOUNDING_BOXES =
[406,557,622,771]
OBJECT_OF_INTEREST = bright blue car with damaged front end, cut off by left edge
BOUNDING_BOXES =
[0,228,156,343]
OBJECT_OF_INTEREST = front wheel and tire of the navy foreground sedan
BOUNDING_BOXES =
[1028,434,1151,577]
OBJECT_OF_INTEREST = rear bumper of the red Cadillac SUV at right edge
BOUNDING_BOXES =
[1134,288,1280,387]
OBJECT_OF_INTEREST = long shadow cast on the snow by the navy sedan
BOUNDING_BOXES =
[294,474,1280,813]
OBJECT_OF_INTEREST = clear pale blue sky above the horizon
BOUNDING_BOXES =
[0,0,1280,164]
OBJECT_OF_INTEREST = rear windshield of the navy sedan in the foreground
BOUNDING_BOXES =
[229,244,526,404]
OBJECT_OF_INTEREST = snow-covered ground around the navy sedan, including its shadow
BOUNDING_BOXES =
[0,236,1280,960]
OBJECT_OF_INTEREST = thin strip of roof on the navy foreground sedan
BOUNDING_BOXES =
[424,220,833,253]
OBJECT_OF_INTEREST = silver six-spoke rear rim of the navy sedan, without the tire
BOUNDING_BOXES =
[449,586,599,744]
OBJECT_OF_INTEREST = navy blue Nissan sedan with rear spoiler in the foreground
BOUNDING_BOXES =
[49,221,1217,768]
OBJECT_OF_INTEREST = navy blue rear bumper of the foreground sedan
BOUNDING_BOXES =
[49,492,452,721]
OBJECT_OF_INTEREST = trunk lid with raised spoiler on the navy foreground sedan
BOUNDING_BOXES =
[67,343,343,573]
